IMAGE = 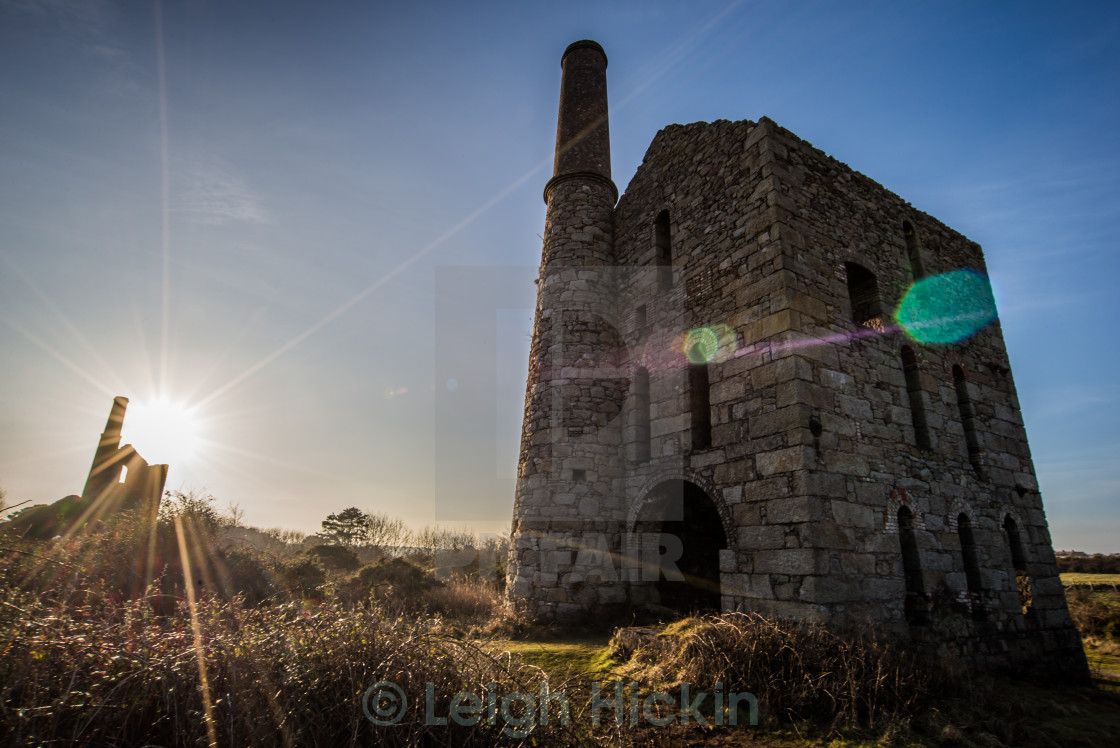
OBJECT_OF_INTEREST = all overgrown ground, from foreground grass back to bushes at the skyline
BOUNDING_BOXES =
[0,506,1120,748]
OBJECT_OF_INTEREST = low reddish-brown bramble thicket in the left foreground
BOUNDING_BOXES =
[0,591,567,746]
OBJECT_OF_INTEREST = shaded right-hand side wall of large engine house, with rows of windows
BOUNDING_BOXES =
[768,118,1080,661]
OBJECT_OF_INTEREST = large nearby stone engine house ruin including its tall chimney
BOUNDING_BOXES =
[507,40,1085,674]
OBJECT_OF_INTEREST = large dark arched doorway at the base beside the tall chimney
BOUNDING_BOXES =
[634,480,728,614]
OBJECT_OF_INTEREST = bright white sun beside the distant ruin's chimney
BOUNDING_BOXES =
[121,398,203,467]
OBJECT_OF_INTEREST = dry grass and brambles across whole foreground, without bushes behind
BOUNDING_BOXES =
[0,587,1120,747]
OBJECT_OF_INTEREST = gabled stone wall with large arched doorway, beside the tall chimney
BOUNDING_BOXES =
[615,121,824,616]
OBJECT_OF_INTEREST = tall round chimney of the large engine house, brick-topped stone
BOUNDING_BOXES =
[508,40,628,618]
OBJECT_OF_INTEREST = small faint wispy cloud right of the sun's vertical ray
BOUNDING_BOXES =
[171,159,269,226]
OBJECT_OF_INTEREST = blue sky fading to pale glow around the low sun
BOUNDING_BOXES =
[0,0,1120,551]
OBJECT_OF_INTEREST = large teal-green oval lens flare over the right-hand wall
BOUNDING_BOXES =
[895,270,996,343]
